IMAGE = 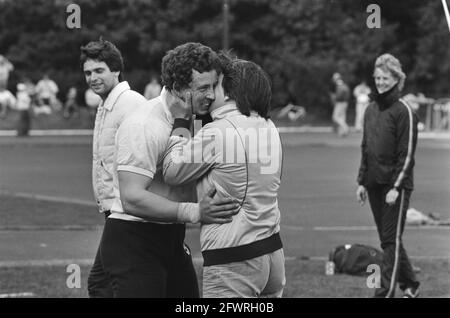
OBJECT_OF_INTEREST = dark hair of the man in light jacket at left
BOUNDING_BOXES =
[80,38,123,81]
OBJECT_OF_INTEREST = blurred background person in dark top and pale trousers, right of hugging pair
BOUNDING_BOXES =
[330,73,350,137]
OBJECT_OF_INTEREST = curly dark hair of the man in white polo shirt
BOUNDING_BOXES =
[161,42,221,91]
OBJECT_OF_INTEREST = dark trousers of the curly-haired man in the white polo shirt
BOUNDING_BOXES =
[99,218,199,298]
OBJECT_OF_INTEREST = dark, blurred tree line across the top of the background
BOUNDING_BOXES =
[0,0,450,116]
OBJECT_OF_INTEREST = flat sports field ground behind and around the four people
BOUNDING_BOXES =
[0,134,450,297]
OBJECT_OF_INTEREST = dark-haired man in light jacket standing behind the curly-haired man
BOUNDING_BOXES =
[80,39,146,297]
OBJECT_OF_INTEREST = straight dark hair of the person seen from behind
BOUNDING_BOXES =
[219,53,272,119]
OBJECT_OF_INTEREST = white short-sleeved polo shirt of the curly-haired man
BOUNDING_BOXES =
[109,89,195,223]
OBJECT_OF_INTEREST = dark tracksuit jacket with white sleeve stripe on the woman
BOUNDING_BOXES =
[358,86,418,190]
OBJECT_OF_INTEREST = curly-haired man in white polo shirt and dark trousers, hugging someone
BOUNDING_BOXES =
[101,43,238,298]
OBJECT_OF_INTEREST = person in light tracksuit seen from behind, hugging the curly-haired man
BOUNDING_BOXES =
[163,56,286,298]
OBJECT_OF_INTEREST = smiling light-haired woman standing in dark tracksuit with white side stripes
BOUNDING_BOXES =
[356,54,419,298]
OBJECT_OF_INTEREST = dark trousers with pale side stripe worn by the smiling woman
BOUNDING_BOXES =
[367,186,419,297]
